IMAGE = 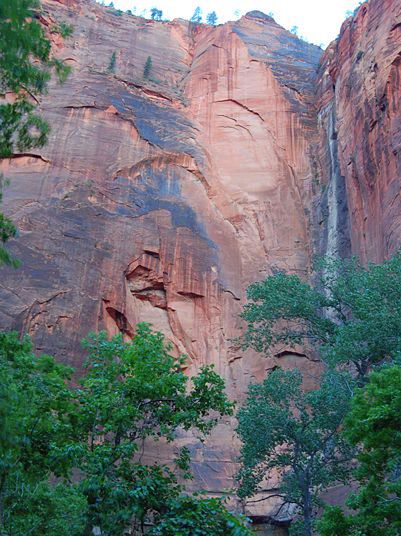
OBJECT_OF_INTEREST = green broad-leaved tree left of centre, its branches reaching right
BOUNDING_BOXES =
[74,324,232,536]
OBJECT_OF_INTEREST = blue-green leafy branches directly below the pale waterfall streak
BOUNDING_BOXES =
[242,254,401,378]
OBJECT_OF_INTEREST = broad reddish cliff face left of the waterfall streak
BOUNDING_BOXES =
[1,0,321,386]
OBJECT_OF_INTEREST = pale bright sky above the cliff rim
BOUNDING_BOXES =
[99,0,360,47]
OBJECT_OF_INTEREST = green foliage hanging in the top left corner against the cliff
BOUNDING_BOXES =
[0,0,69,158]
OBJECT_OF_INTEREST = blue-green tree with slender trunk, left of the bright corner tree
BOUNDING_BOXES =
[237,369,352,536]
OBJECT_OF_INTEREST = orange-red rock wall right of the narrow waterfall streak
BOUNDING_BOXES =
[319,0,401,262]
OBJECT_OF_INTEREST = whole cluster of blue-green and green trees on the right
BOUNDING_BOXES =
[237,254,401,536]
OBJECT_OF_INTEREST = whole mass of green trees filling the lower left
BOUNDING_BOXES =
[0,324,249,536]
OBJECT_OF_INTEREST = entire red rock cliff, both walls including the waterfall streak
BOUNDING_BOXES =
[0,0,401,514]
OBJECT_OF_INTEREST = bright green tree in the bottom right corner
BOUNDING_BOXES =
[318,365,401,536]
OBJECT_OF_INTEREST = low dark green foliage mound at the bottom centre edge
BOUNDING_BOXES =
[148,496,253,536]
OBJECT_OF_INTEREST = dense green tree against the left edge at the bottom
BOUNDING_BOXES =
[0,333,86,536]
